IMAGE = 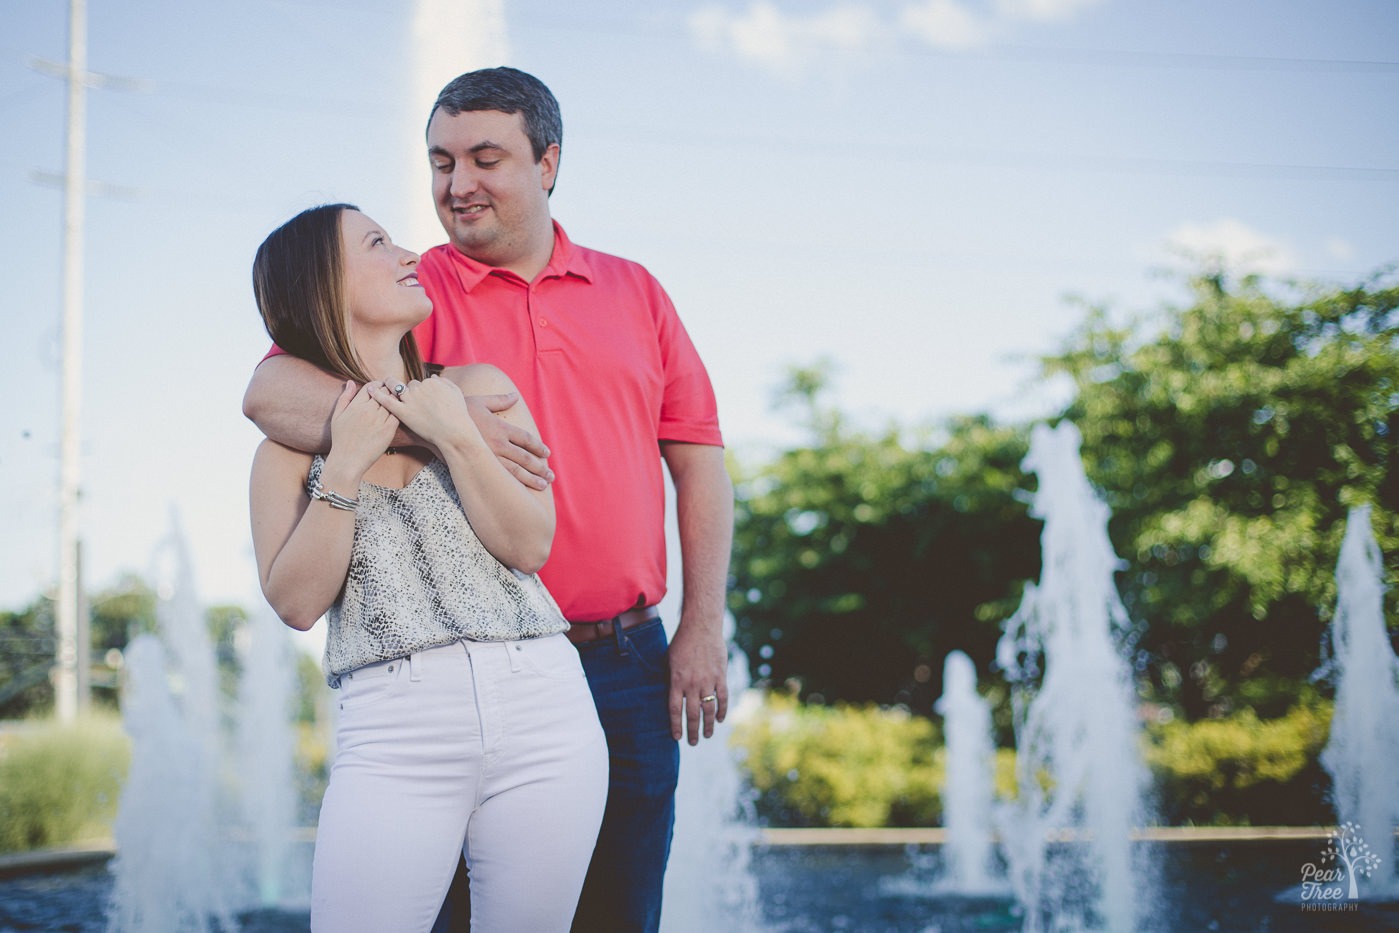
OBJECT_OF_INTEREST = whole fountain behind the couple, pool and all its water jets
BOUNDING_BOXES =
[16,436,1399,933]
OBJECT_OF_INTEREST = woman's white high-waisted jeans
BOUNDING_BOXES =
[311,635,607,933]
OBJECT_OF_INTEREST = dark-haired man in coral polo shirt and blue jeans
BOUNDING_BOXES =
[243,69,733,933]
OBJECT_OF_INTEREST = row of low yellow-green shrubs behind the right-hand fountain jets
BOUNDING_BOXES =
[732,692,1335,827]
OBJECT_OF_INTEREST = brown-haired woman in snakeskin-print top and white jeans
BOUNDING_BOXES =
[250,204,607,933]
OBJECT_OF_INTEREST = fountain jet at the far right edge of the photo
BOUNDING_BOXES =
[1321,505,1399,901]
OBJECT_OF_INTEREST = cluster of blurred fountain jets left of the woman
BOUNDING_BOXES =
[108,520,309,933]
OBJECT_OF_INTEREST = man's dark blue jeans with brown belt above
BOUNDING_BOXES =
[432,620,680,933]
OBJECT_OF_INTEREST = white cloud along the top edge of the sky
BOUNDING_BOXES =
[688,0,1107,74]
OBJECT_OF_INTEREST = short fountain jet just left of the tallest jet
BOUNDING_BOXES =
[935,652,1006,895]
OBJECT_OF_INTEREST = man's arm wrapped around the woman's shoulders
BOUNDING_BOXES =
[243,354,554,490]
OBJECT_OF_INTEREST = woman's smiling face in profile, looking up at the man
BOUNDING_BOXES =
[340,210,432,336]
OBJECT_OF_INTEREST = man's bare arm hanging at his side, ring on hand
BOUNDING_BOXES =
[660,441,733,746]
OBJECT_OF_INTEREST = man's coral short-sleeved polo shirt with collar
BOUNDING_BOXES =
[414,224,723,622]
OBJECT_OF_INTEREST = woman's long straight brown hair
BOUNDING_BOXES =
[253,204,422,383]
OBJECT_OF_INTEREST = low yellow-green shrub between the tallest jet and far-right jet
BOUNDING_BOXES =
[1146,694,1335,825]
